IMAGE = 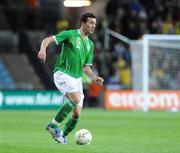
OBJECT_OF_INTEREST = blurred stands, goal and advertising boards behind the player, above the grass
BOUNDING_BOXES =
[0,0,180,110]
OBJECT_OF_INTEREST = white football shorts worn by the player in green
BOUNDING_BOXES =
[54,71,84,107]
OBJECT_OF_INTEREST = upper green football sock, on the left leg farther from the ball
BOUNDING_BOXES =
[55,100,76,123]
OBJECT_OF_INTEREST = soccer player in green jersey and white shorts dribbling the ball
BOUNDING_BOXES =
[38,12,104,144]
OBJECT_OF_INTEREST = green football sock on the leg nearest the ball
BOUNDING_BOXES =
[63,117,79,136]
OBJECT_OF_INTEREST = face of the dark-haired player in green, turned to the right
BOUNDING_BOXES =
[84,18,96,34]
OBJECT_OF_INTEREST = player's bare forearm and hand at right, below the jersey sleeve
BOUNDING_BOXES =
[84,65,104,86]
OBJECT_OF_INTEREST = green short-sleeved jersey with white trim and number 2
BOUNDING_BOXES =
[53,29,94,78]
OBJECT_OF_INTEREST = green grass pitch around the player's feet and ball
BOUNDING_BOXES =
[0,109,180,153]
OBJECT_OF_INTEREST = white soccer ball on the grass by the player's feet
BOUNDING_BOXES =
[75,129,92,145]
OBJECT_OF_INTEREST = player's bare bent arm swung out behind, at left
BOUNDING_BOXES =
[38,36,55,62]
